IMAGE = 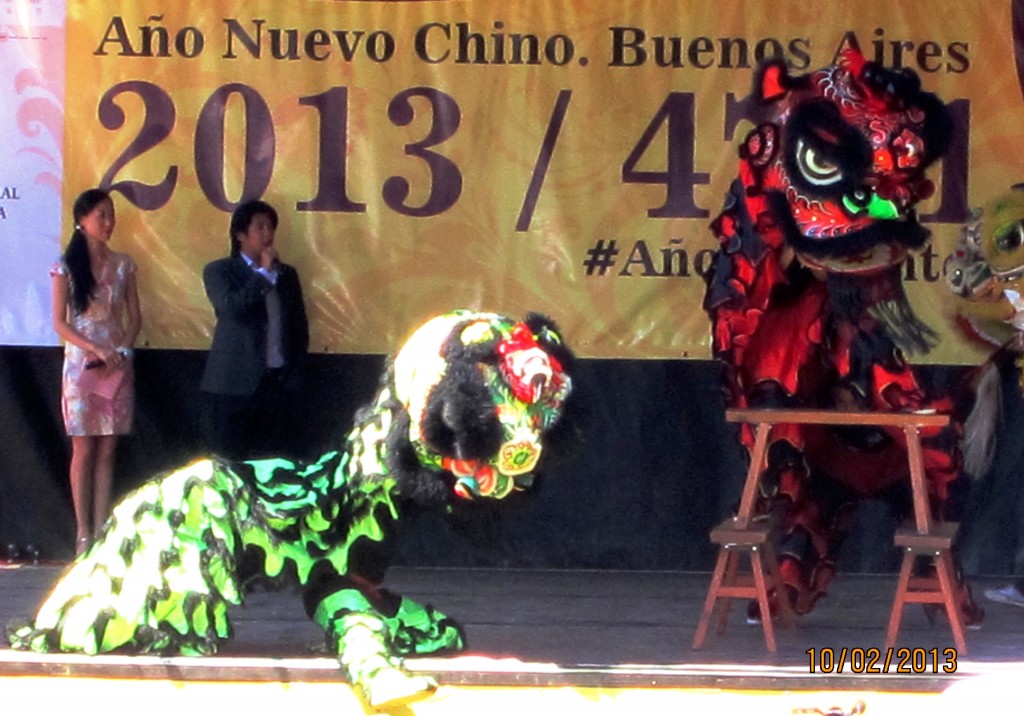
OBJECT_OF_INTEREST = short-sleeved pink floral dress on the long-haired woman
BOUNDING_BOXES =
[50,252,136,435]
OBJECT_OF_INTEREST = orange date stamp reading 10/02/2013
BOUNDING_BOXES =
[806,646,956,674]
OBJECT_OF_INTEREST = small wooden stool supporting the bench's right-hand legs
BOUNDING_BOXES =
[886,522,967,655]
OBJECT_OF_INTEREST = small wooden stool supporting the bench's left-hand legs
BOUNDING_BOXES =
[693,517,793,651]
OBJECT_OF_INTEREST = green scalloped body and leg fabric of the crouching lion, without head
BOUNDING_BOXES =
[8,387,462,656]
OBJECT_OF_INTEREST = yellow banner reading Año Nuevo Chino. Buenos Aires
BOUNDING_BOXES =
[65,0,1024,363]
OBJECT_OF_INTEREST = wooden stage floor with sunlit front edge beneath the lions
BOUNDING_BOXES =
[0,565,1024,716]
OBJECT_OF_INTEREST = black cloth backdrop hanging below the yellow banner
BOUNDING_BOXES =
[0,347,1024,575]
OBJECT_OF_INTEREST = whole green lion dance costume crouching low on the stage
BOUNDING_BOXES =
[8,310,572,708]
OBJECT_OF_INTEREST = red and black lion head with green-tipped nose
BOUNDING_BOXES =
[740,50,950,272]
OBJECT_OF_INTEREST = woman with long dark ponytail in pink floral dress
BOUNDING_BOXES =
[50,188,142,553]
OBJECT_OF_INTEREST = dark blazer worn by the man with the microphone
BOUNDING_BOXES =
[201,255,309,395]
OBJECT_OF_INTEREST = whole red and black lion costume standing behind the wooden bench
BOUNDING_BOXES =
[705,52,982,624]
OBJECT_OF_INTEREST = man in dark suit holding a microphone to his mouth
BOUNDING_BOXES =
[201,201,309,460]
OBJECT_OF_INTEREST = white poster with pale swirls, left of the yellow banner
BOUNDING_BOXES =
[0,0,65,345]
